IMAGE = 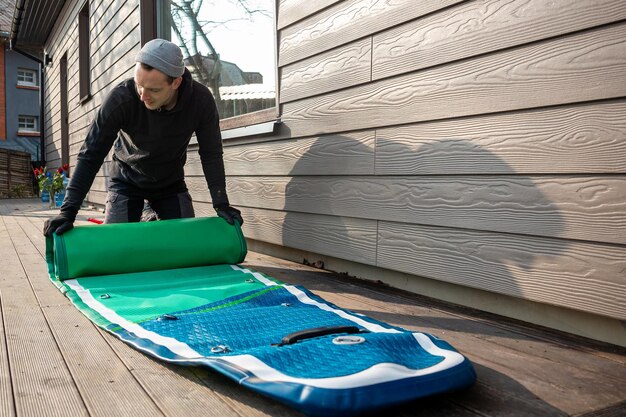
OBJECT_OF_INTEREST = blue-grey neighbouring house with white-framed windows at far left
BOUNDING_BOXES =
[0,2,41,161]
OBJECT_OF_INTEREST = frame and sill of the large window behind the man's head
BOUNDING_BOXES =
[140,0,280,138]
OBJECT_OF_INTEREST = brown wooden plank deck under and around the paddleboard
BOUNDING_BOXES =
[0,199,626,417]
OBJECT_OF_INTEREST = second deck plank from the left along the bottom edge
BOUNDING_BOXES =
[0,206,88,417]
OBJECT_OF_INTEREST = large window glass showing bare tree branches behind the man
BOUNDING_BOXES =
[155,0,277,129]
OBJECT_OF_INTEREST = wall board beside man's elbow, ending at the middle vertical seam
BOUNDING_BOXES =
[185,131,374,176]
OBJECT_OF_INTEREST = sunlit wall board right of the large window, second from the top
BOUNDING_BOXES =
[278,0,461,66]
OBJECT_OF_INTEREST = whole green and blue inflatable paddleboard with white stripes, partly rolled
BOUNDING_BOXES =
[47,218,476,416]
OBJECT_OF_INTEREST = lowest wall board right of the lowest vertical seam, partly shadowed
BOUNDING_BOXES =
[377,222,626,320]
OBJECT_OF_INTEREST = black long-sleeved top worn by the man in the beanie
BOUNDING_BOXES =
[61,69,228,216]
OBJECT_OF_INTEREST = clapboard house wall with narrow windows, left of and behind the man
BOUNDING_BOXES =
[44,0,140,187]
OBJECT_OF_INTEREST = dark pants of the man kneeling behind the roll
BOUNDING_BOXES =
[104,191,195,223]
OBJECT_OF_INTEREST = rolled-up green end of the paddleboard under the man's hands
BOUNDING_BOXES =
[47,217,247,281]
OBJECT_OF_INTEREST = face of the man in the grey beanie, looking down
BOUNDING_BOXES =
[135,63,182,110]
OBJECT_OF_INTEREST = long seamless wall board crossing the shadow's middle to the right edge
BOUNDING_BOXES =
[187,175,626,244]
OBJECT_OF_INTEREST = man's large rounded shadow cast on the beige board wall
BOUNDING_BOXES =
[283,133,568,305]
